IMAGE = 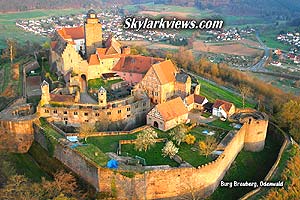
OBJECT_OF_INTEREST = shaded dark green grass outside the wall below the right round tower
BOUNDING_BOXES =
[209,130,281,200]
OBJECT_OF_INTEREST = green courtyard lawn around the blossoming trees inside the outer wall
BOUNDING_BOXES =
[87,127,221,167]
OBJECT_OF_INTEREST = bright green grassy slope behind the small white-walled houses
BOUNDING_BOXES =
[198,79,254,108]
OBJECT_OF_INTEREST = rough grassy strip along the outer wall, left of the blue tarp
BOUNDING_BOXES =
[75,144,108,167]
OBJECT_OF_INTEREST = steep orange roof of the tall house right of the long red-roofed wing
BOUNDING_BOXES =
[152,60,177,85]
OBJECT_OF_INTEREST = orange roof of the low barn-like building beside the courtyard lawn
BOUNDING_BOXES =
[156,97,188,121]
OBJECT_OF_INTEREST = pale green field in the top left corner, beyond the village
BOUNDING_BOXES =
[0,9,84,49]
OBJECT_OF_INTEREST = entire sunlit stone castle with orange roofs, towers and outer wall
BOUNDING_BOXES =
[0,10,268,199]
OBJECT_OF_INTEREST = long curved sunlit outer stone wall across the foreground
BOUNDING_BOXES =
[35,109,267,199]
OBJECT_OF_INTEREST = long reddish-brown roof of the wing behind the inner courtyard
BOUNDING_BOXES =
[112,55,163,74]
